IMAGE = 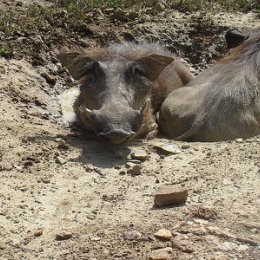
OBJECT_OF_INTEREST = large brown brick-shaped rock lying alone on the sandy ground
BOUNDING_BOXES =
[154,185,188,207]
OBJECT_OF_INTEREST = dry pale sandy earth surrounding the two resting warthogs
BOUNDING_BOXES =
[0,1,260,260]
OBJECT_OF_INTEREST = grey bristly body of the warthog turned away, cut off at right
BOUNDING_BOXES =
[158,31,260,141]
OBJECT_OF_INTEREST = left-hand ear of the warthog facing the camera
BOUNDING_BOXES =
[57,52,97,80]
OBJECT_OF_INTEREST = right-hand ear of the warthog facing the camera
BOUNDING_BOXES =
[136,54,174,81]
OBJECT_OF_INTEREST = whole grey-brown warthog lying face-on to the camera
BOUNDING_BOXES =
[58,43,192,144]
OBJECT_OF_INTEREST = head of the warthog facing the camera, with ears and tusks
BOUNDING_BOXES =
[58,45,173,143]
